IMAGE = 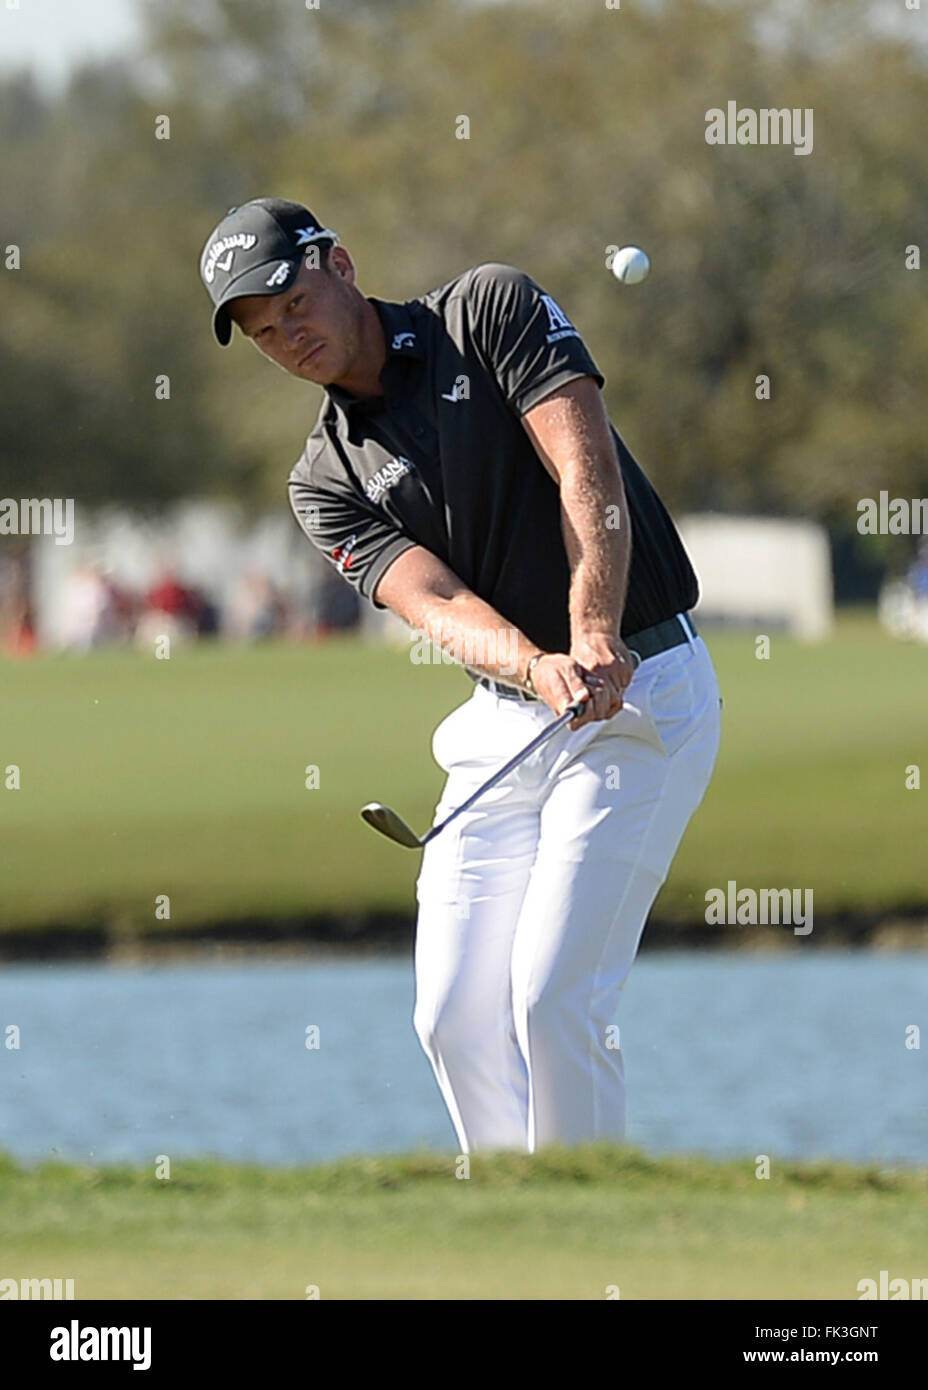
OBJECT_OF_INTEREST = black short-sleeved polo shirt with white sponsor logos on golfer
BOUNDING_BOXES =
[289,263,699,652]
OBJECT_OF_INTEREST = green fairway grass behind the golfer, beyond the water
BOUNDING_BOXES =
[0,616,928,930]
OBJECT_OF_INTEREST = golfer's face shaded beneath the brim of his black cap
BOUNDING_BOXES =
[229,246,363,386]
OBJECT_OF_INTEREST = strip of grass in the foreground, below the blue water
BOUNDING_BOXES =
[0,1144,928,1300]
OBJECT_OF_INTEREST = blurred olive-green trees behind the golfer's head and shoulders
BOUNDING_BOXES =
[0,0,928,592]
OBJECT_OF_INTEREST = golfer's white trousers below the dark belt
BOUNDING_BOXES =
[413,625,721,1154]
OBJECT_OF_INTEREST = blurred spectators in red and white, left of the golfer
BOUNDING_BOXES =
[0,556,360,656]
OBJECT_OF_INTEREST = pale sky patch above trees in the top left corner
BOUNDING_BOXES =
[0,0,138,88]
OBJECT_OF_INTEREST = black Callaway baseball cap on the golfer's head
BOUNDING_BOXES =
[200,197,338,348]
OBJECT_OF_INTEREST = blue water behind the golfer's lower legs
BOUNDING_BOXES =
[0,951,928,1165]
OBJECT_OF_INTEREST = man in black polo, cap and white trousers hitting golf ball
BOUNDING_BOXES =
[200,197,721,1152]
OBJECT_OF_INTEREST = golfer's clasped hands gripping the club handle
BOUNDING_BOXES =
[532,632,635,728]
